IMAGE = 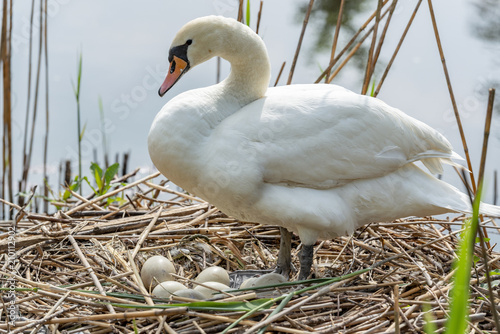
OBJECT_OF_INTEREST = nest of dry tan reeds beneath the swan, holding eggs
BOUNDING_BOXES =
[0,173,500,333]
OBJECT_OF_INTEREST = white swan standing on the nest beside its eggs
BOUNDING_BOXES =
[148,16,500,280]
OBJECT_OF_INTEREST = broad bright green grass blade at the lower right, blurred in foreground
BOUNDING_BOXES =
[446,185,482,334]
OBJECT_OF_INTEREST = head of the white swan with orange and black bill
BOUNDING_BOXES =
[158,16,269,96]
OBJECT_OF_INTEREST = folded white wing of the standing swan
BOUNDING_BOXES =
[214,85,455,189]
